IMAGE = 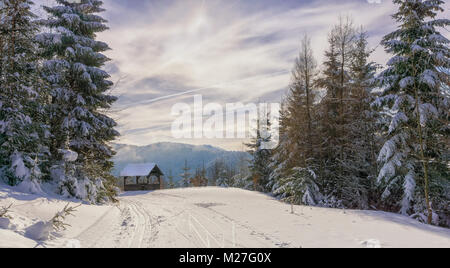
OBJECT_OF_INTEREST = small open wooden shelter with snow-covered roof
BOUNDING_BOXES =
[120,163,164,192]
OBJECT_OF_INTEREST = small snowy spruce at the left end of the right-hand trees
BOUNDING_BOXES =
[246,109,272,192]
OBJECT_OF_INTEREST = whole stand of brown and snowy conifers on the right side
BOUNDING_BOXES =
[241,0,450,226]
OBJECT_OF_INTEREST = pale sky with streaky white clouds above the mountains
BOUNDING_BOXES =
[33,0,450,150]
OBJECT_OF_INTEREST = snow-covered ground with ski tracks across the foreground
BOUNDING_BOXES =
[0,185,450,248]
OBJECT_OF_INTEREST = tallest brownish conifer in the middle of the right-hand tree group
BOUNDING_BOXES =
[320,17,356,205]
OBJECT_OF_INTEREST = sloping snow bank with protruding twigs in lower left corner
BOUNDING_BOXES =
[0,183,112,248]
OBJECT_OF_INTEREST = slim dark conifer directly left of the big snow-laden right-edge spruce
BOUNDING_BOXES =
[340,30,379,209]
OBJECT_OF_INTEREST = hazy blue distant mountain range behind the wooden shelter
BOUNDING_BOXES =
[113,142,250,181]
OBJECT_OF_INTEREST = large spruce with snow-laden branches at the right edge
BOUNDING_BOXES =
[375,0,450,224]
